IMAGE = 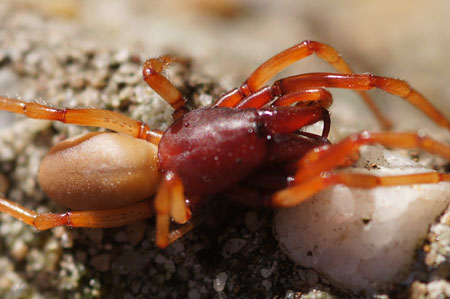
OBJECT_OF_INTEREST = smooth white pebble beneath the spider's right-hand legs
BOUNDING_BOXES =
[274,147,450,293]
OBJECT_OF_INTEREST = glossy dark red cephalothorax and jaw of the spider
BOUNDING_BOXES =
[158,107,329,196]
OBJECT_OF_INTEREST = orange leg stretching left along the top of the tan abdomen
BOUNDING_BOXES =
[0,96,162,145]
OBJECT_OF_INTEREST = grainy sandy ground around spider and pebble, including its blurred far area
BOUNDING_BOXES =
[0,0,450,298]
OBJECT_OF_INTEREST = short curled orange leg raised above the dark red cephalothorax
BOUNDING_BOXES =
[142,55,187,119]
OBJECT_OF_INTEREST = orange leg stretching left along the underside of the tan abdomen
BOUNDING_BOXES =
[0,197,154,230]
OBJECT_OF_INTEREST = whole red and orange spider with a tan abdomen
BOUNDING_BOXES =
[0,41,450,247]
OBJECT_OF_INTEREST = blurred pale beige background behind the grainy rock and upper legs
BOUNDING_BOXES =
[7,0,450,133]
